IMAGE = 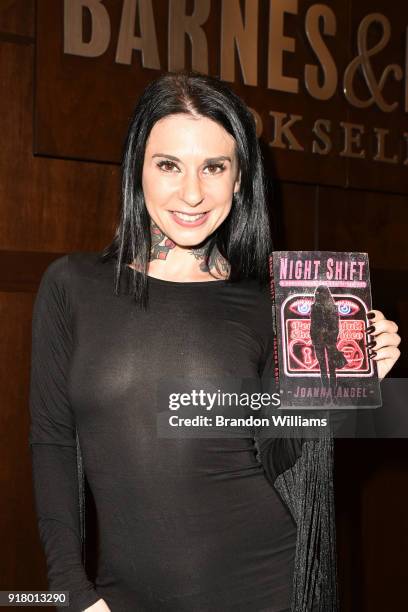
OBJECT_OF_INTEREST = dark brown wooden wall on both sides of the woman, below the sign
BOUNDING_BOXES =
[0,0,408,612]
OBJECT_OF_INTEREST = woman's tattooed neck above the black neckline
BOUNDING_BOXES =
[132,221,230,282]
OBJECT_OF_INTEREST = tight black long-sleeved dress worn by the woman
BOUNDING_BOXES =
[29,253,296,612]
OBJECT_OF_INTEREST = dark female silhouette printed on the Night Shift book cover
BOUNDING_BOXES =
[310,285,347,397]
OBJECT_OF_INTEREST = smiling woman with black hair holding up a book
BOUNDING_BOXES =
[30,73,399,612]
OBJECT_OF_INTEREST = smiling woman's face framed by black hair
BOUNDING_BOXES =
[142,114,239,247]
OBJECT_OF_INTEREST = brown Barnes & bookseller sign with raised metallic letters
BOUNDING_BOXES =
[37,0,408,191]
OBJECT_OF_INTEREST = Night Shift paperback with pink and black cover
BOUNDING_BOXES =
[269,251,381,408]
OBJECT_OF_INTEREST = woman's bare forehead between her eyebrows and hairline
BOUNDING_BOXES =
[146,113,235,156]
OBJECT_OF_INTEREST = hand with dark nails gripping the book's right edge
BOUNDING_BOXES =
[367,310,401,380]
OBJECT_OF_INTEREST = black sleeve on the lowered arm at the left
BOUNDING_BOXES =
[29,255,101,612]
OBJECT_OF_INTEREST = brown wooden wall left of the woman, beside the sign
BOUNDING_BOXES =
[0,0,119,610]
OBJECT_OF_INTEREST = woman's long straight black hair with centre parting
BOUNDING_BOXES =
[100,70,272,308]
